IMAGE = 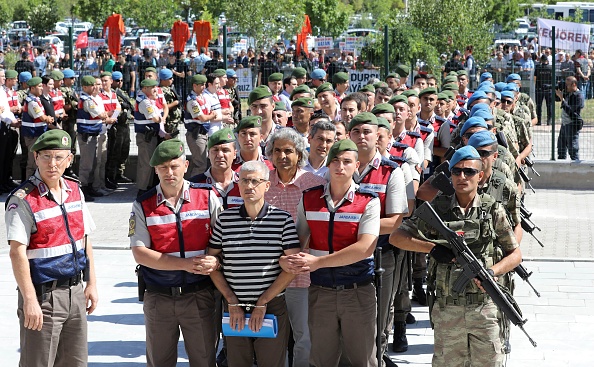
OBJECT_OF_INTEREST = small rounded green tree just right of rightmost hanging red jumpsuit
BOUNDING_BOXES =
[305,0,353,37]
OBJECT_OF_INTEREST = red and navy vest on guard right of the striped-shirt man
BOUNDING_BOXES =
[303,186,376,287]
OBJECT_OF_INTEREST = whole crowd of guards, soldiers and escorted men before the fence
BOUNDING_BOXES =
[0,39,583,367]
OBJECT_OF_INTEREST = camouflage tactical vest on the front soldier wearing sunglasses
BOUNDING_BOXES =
[418,194,498,307]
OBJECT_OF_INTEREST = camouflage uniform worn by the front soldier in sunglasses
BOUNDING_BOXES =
[400,194,518,367]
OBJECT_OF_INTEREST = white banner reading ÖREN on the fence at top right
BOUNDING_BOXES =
[538,18,590,53]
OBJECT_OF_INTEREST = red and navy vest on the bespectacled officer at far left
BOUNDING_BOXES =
[6,178,87,284]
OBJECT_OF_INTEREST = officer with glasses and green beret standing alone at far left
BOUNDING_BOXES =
[5,129,98,367]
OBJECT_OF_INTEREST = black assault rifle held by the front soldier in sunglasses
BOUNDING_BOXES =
[415,202,536,347]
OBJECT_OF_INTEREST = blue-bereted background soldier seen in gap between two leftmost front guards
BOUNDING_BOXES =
[105,71,134,188]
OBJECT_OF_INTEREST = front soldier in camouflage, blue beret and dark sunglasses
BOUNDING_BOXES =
[390,146,522,366]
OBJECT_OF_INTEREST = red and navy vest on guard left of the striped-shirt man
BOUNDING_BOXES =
[139,183,211,287]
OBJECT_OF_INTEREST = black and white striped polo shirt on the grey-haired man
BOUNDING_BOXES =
[208,203,299,303]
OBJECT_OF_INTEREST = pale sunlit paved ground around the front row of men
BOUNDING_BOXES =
[0,185,594,367]
